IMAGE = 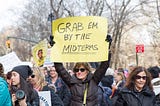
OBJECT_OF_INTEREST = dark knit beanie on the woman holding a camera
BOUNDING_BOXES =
[12,65,33,80]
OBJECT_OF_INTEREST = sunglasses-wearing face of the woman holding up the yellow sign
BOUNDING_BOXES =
[74,66,88,80]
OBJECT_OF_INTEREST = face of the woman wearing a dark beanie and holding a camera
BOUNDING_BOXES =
[11,71,20,86]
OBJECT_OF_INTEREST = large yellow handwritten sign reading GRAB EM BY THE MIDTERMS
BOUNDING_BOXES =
[51,16,109,62]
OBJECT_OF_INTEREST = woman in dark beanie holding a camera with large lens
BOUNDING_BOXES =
[10,65,39,106]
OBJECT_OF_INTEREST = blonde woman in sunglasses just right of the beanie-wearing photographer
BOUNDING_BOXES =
[28,67,64,106]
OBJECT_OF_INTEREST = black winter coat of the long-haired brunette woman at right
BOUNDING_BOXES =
[113,87,155,106]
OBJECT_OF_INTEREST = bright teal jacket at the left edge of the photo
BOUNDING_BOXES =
[0,77,12,106]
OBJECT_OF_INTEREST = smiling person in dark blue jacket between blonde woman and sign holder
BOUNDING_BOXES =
[46,66,71,106]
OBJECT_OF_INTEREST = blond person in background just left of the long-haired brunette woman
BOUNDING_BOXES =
[111,71,125,98]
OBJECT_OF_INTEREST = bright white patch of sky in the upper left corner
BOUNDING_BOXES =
[0,0,25,30]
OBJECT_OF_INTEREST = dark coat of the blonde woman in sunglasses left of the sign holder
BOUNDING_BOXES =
[42,85,64,106]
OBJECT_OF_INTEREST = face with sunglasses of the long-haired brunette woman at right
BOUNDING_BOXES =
[135,71,146,91]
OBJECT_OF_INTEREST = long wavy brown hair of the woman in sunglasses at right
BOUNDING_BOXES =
[125,66,153,91]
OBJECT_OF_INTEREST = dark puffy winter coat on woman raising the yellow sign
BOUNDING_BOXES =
[55,61,109,106]
